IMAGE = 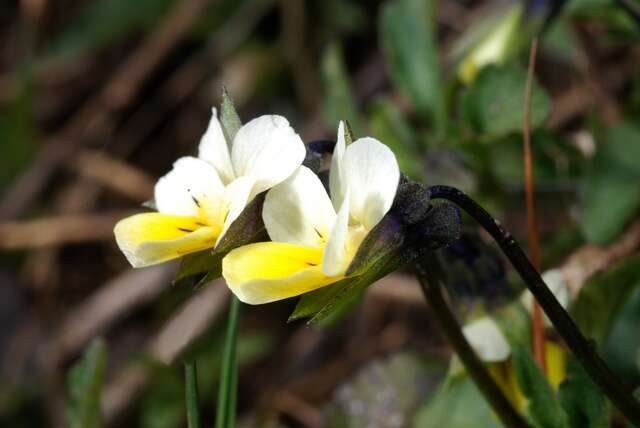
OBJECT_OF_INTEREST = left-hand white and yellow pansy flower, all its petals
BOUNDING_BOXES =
[114,109,306,267]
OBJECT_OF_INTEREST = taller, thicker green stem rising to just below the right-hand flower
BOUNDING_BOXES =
[216,296,240,428]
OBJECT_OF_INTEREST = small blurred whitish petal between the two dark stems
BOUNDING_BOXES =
[462,317,511,363]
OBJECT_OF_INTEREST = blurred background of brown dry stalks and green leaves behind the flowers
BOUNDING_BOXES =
[0,0,640,428]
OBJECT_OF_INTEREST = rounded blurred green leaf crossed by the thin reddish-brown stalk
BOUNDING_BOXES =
[462,65,550,137]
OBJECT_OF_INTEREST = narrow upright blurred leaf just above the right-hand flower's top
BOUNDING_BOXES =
[321,44,364,135]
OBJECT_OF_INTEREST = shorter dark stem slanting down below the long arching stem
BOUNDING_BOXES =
[416,256,529,428]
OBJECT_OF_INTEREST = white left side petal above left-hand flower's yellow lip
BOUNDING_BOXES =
[155,157,226,221]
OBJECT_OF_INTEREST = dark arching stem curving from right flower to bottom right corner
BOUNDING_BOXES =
[429,186,640,426]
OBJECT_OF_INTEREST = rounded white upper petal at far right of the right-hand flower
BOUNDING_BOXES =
[342,137,400,230]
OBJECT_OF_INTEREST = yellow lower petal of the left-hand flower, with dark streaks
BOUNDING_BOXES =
[113,213,219,267]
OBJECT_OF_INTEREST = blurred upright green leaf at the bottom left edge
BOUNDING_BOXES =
[66,339,107,428]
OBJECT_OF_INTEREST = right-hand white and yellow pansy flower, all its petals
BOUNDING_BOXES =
[222,122,400,304]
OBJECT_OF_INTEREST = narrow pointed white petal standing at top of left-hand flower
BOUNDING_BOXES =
[198,108,235,183]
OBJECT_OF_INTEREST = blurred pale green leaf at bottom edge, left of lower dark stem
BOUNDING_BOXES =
[413,376,501,428]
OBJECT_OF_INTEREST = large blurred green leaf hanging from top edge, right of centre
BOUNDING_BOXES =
[379,0,446,134]
